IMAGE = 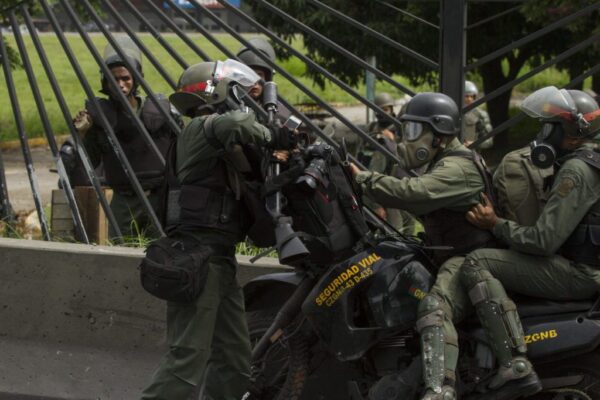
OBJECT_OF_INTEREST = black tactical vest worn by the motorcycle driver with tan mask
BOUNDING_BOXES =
[423,151,498,265]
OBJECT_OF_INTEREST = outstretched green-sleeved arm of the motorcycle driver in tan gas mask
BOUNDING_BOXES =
[356,160,483,215]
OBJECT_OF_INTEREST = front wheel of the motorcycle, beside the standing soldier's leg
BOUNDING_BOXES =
[246,310,309,400]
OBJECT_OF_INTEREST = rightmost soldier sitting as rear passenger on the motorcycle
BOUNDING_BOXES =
[460,87,600,400]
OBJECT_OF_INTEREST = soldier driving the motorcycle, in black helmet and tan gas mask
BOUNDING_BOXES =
[353,93,493,400]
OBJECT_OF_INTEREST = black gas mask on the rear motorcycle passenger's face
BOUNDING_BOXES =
[529,122,566,169]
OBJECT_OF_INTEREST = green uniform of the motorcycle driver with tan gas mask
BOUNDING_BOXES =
[356,139,485,384]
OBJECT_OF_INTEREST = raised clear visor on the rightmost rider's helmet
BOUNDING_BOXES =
[521,86,577,121]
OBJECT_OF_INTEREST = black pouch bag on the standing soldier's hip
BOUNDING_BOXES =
[140,237,214,303]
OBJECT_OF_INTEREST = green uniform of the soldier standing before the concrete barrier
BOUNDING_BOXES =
[142,111,271,400]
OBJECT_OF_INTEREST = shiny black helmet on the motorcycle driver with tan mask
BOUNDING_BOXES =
[400,92,460,135]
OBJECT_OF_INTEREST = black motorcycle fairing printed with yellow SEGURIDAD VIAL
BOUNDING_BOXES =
[302,242,433,361]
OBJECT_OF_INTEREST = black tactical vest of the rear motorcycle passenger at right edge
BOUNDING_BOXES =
[559,149,600,267]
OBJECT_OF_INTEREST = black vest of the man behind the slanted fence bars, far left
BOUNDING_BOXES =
[86,96,172,190]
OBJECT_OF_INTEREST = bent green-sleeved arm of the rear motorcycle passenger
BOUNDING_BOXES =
[493,160,600,256]
